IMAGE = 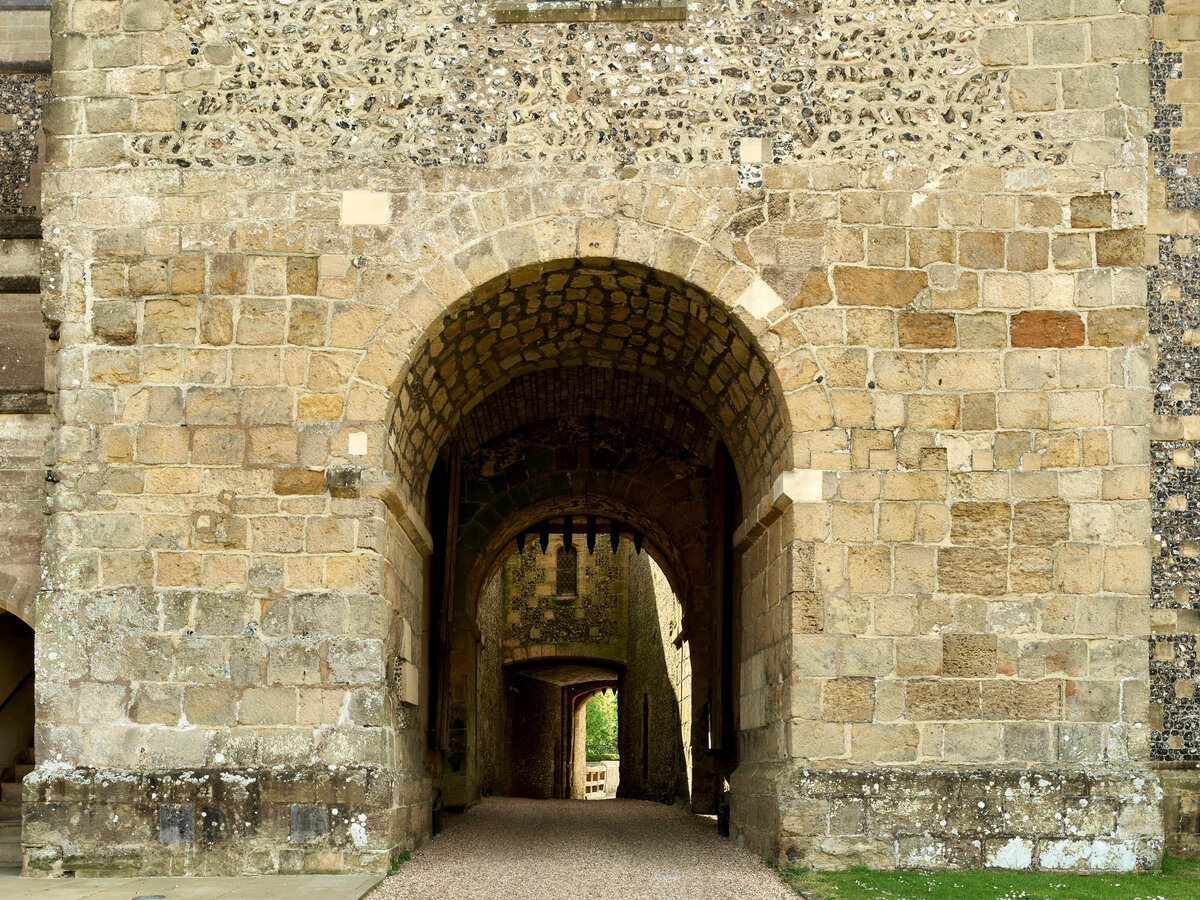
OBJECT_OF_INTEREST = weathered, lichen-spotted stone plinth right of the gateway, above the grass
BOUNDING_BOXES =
[731,761,1163,872]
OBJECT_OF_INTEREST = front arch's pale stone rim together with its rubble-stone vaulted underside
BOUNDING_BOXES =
[346,216,832,508]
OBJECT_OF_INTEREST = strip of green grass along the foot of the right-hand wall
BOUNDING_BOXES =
[780,857,1200,900]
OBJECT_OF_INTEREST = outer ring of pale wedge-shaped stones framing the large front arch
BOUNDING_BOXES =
[342,213,833,518]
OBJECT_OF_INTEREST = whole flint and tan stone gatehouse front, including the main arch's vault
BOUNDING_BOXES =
[0,0,1200,876]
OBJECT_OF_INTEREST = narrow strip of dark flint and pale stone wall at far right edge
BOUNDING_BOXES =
[1147,4,1200,854]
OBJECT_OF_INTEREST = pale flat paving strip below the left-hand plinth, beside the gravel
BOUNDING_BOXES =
[0,872,379,900]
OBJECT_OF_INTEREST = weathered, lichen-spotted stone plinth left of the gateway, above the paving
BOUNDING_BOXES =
[22,763,432,877]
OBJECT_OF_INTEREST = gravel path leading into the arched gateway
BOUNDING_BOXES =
[370,798,797,900]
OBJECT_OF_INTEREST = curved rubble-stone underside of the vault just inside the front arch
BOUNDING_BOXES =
[391,260,791,508]
